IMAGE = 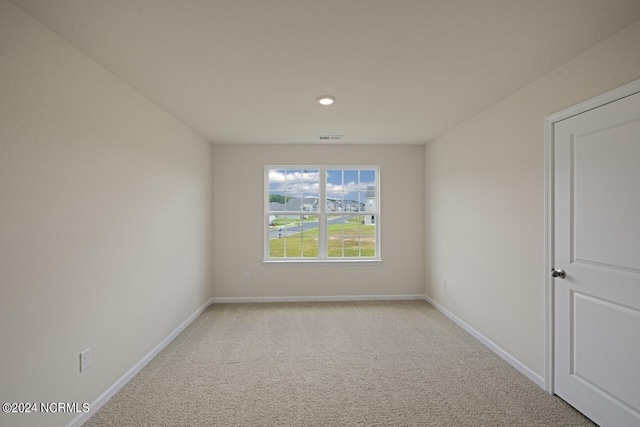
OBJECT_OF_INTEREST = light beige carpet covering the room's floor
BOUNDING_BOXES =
[85,301,593,427]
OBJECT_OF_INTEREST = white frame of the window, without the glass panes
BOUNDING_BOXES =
[262,164,382,265]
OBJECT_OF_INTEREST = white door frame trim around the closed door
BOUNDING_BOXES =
[544,79,640,394]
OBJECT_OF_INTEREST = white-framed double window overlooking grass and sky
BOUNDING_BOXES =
[264,165,380,262]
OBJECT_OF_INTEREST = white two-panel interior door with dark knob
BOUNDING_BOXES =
[553,88,640,427]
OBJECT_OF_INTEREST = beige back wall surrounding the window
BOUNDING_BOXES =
[213,144,424,297]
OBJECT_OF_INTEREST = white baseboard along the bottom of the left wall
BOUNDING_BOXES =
[67,298,213,427]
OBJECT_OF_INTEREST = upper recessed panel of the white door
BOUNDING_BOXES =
[570,119,640,272]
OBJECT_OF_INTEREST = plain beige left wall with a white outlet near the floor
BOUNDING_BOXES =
[0,0,212,426]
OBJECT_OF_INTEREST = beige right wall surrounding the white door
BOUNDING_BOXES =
[425,22,640,376]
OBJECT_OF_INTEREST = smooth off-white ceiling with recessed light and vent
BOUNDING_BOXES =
[12,0,640,144]
